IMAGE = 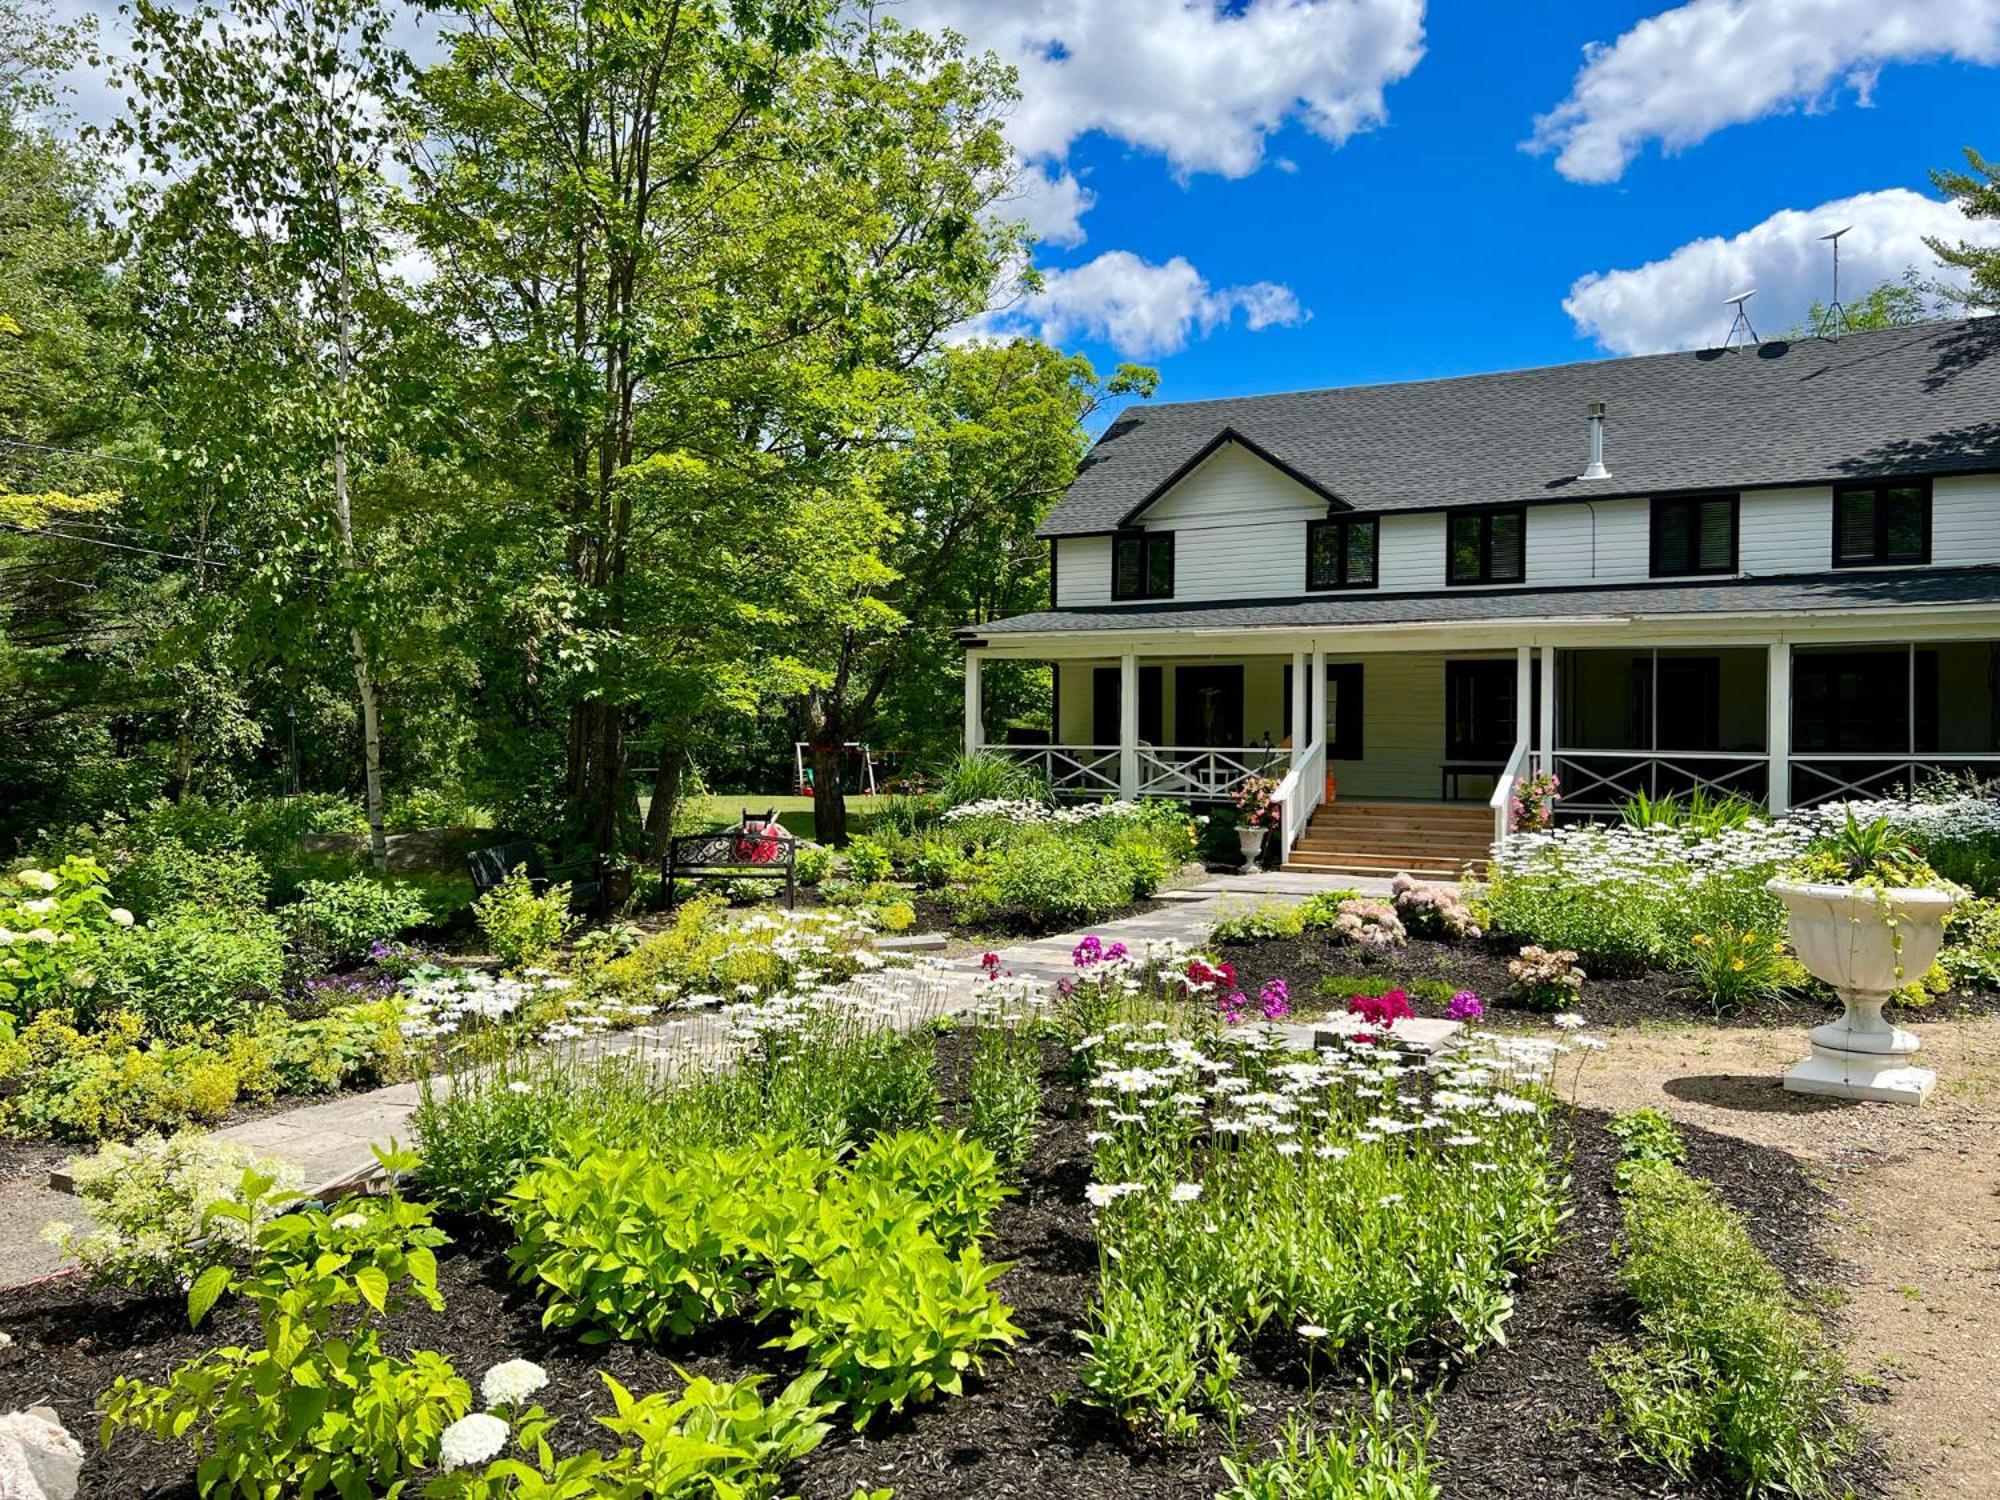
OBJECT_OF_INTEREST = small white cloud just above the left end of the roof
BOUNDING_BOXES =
[968,250,1310,360]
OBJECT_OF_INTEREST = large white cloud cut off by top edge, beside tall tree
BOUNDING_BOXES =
[896,0,1424,178]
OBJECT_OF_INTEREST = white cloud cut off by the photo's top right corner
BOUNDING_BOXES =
[1530,0,2000,182]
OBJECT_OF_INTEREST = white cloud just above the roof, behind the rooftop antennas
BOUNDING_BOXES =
[1562,188,2000,354]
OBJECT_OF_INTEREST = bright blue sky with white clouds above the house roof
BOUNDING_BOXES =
[928,0,2000,400]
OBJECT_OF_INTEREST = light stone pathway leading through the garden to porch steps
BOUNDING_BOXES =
[0,872,1388,1286]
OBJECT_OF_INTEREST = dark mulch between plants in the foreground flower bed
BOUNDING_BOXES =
[0,1044,1874,1500]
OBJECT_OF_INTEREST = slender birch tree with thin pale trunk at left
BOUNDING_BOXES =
[122,0,402,868]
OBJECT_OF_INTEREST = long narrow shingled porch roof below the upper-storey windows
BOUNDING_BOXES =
[976,568,2000,638]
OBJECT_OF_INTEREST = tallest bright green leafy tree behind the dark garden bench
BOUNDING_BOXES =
[410,0,1014,850]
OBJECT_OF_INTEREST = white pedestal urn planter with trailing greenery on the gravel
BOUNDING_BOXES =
[1766,810,1964,1104]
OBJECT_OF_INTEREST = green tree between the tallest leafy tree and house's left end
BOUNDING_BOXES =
[788,338,1158,842]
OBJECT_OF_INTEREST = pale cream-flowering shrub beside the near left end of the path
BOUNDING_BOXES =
[42,1130,302,1292]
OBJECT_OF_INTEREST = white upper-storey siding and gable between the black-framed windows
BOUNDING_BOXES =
[1056,444,2000,606]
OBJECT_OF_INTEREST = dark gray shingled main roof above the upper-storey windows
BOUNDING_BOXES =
[1040,318,2000,536]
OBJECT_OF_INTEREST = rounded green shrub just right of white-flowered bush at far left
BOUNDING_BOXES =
[84,906,284,1036]
